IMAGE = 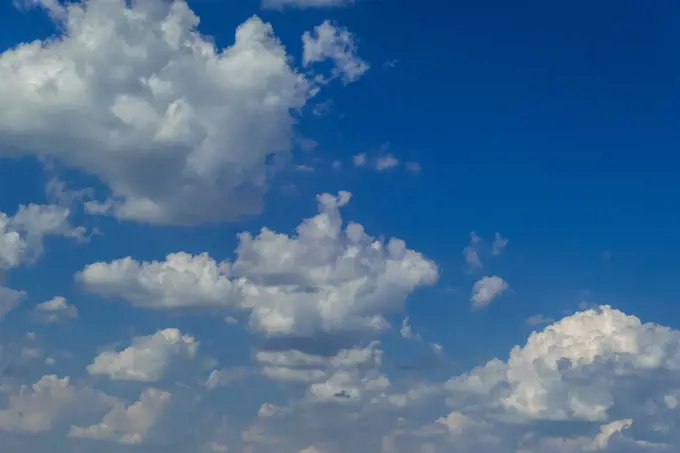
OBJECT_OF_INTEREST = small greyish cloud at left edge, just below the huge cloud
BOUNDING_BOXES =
[0,204,85,271]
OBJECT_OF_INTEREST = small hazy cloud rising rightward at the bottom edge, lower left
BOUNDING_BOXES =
[69,388,171,445]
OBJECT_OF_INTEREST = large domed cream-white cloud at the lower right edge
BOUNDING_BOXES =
[447,306,680,422]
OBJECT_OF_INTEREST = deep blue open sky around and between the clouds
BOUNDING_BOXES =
[0,0,680,448]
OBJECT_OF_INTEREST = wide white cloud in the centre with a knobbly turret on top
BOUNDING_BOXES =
[76,192,438,336]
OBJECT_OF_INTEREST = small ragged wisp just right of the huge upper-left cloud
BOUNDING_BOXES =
[302,21,370,84]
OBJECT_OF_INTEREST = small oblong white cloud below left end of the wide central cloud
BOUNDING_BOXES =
[87,329,199,382]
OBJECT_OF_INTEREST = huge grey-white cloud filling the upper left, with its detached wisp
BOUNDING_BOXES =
[0,0,368,224]
